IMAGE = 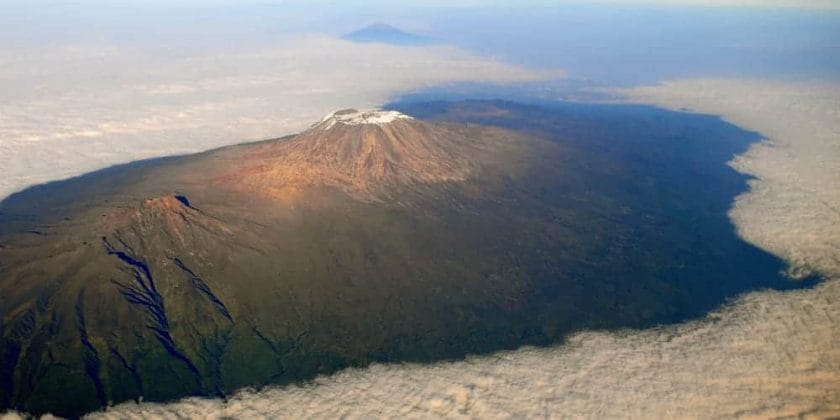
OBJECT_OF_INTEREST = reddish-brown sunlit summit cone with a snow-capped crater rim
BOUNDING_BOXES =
[209,110,522,199]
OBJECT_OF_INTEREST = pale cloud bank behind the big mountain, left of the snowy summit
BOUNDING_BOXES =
[0,37,559,199]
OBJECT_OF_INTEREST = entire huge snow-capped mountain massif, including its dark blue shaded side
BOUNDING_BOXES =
[0,102,790,416]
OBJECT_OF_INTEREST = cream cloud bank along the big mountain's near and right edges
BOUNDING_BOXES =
[64,81,840,419]
